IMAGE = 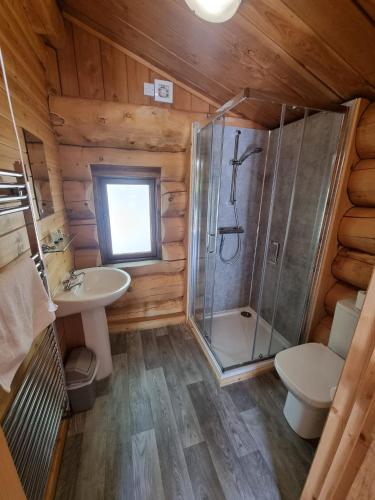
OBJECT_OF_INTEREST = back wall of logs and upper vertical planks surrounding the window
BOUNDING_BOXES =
[50,21,217,333]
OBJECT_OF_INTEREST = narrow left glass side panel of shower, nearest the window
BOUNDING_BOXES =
[192,118,224,352]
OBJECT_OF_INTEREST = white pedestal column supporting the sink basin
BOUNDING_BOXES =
[81,307,113,380]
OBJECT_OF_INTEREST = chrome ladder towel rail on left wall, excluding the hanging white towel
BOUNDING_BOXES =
[0,165,69,500]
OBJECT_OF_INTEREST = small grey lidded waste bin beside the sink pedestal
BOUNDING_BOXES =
[65,347,98,413]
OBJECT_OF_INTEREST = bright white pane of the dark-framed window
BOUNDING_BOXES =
[107,184,151,255]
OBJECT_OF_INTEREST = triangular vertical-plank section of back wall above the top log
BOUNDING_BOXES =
[55,20,212,113]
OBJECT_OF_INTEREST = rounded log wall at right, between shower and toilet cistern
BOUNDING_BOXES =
[309,100,375,344]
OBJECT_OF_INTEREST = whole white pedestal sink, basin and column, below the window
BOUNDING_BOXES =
[53,267,131,380]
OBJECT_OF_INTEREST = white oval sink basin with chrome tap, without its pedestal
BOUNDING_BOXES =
[53,267,131,318]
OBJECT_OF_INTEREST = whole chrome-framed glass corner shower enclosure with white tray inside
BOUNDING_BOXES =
[189,89,346,371]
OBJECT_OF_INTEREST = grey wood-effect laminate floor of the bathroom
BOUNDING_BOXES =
[56,326,314,500]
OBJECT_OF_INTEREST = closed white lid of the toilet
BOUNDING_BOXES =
[275,343,344,408]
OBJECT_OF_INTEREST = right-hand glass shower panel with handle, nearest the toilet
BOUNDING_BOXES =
[252,106,343,360]
